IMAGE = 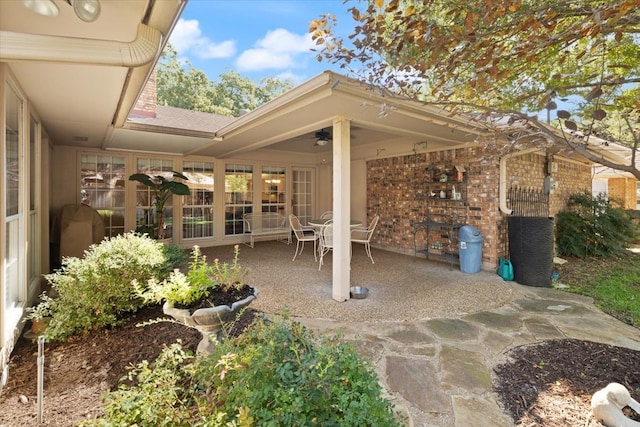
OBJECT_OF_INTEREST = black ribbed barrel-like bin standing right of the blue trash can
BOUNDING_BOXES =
[507,216,553,287]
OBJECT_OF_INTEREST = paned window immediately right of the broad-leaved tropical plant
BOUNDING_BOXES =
[182,161,214,239]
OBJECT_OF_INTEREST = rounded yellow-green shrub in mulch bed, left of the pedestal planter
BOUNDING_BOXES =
[45,233,167,340]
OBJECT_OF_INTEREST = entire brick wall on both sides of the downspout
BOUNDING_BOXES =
[367,147,591,269]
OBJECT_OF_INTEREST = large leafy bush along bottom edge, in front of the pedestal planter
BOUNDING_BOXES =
[84,319,401,427]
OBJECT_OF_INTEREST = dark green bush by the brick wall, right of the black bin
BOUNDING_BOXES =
[556,193,637,258]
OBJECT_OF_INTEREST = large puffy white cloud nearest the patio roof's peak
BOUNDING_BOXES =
[236,28,314,71]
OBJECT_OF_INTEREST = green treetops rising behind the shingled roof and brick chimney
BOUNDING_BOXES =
[156,45,294,117]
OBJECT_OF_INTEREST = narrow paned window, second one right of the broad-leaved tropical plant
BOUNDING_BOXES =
[224,164,253,236]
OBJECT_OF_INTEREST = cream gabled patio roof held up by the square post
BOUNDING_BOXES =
[103,71,490,158]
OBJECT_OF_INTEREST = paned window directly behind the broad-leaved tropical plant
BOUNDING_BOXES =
[136,158,174,238]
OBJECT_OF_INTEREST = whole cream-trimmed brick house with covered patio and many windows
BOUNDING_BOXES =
[0,0,628,390]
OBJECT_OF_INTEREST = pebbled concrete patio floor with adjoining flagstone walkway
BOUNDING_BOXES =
[203,242,640,427]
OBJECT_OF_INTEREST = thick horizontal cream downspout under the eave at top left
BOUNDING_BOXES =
[0,24,162,67]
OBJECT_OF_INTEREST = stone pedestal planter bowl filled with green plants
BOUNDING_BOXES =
[141,245,258,354]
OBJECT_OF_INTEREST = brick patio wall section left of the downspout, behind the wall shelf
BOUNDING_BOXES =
[367,148,501,264]
